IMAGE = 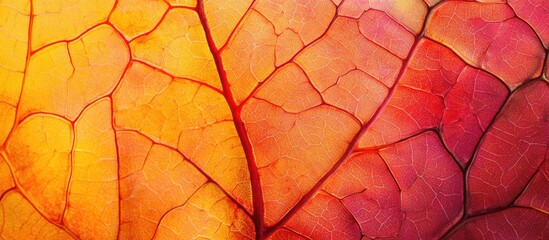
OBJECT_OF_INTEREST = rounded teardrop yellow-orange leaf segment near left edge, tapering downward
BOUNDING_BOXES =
[6,114,73,221]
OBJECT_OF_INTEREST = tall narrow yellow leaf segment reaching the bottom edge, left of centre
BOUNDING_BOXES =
[64,98,119,239]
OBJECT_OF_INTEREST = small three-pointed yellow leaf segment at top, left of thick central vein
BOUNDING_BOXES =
[130,8,221,89]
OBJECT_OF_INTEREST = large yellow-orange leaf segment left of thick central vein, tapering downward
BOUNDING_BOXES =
[113,63,251,212]
